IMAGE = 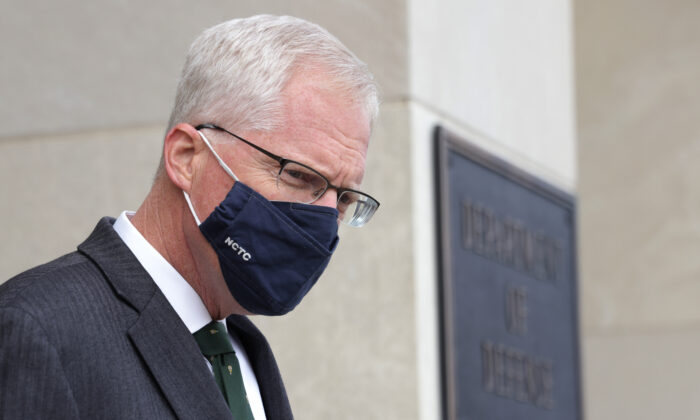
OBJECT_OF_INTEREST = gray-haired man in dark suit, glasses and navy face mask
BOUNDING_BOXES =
[0,16,379,420]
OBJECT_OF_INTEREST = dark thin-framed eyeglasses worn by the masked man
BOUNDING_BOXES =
[195,124,379,227]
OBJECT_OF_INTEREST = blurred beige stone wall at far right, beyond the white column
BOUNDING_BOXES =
[575,0,700,420]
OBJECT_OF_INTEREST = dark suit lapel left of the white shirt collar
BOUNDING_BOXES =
[78,218,232,419]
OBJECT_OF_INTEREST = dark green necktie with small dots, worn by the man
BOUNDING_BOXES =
[193,321,254,420]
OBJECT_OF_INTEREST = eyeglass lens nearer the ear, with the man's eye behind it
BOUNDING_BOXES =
[277,162,328,204]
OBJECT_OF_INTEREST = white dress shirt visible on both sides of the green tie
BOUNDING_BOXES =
[114,211,266,420]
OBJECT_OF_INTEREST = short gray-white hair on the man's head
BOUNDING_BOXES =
[168,15,379,131]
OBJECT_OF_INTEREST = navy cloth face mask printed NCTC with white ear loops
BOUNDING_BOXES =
[183,133,338,315]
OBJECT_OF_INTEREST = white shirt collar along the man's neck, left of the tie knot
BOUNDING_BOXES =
[114,211,211,333]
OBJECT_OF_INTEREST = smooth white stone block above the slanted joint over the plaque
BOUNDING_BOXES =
[409,0,576,191]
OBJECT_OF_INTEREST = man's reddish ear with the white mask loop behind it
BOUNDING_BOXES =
[163,123,199,191]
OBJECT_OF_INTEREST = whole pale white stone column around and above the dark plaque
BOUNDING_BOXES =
[408,0,576,420]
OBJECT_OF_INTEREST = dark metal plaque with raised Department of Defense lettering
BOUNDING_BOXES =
[435,127,581,420]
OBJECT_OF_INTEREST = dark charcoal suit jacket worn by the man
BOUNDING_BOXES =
[0,218,292,420]
